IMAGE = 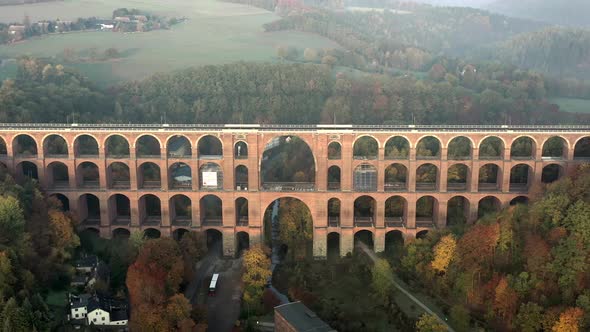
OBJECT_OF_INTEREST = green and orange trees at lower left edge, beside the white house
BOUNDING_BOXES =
[0,171,80,331]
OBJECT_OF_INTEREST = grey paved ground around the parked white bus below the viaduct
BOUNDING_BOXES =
[184,243,242,332]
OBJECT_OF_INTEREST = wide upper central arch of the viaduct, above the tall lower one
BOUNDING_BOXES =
[259,135,317,191]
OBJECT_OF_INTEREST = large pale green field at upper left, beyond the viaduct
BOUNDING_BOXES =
[0,0,338,83]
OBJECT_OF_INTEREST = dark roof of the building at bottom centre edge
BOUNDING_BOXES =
[275,302,336,332]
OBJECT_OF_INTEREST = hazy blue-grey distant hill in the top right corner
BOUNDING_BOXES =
[488,0,590,27]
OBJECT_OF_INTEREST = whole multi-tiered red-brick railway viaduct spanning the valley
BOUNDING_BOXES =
[0,124,590,257]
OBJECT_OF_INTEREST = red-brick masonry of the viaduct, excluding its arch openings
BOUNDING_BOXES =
[0,128,590,257]
